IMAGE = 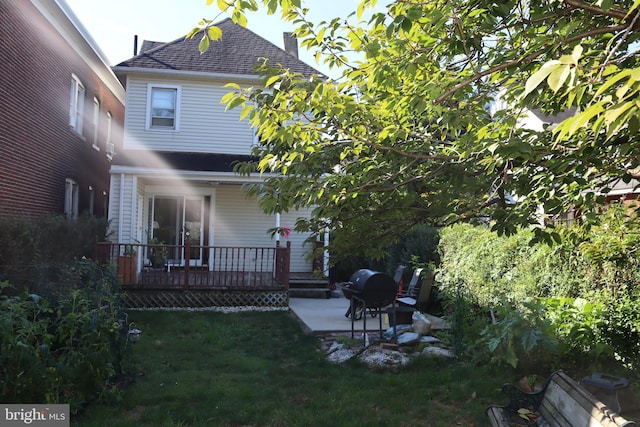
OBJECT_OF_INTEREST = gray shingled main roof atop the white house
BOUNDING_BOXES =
[116,18,321,76]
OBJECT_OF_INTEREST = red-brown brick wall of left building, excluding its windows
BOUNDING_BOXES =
[0,0,124,217]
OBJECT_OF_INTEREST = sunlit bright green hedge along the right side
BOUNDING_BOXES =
[437,205,640,367]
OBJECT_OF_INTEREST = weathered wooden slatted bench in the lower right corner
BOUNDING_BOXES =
[487,371,636,427]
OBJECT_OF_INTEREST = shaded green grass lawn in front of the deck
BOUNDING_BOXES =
[72,312,514,427]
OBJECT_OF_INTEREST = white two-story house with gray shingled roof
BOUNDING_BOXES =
[109,19,320,294]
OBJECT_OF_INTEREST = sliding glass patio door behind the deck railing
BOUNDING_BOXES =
[149,195,204,265]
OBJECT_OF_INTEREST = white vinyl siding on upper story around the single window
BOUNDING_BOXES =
[124,76,254,155]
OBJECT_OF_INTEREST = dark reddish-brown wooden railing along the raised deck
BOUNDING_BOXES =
[96,241,291,290]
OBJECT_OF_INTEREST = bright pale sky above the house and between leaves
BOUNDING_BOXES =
[65,0,368,76]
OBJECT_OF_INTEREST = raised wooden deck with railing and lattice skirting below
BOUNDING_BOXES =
[96,241,291,308]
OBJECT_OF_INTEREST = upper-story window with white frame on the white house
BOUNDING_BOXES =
[146,84,180,131]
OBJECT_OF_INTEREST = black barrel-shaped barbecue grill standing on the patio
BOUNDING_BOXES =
[337,269,398,341]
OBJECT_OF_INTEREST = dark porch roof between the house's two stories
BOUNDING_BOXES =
[112,150,258,172]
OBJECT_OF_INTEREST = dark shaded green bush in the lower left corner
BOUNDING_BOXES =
[0,260,125,413]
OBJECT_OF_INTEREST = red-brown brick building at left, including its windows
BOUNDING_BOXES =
[0,0,125,217]
